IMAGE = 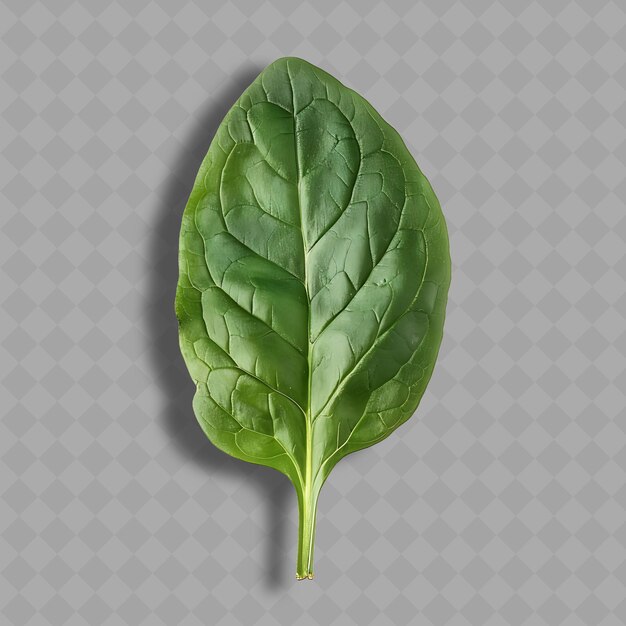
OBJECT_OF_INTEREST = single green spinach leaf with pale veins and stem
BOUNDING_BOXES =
[176,58,450,578]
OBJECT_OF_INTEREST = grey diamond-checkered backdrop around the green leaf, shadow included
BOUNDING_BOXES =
[0,0,626,626]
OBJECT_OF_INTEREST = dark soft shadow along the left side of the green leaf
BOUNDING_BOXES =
[145,65,295,589]
